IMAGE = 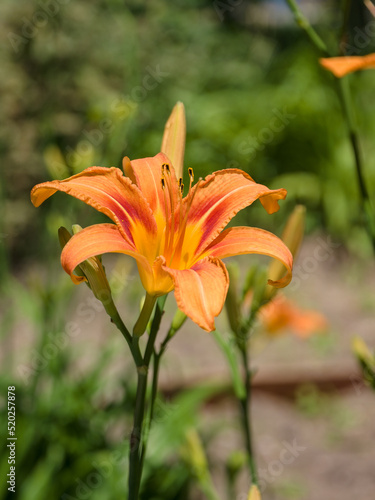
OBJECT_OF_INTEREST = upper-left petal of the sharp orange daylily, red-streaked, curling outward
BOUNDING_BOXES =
[31,167,157,255]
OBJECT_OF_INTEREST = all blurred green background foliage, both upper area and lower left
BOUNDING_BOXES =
[0,0,375,500]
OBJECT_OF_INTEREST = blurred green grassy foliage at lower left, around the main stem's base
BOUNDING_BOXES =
[0,274,223,500]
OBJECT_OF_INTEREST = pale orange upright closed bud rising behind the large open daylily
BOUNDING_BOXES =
[161,102,186,179]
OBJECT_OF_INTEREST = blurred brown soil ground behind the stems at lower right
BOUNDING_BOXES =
[5,236,375,500]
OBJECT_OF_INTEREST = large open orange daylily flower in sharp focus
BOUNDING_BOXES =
[31,153,293,331]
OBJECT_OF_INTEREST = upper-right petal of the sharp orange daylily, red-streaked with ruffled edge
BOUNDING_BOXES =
[184,169,286,255]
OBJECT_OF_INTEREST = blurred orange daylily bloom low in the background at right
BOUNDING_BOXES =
[259,295,327,338]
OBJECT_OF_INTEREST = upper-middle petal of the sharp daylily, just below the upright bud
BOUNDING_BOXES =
[123,153,179,232]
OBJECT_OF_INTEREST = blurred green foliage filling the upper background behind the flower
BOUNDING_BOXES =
[0,0,375,278]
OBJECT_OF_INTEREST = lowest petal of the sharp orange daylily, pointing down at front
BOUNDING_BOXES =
[164,257,229,332]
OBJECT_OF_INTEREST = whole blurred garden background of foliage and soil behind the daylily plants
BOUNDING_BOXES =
[0,0,375,500]
